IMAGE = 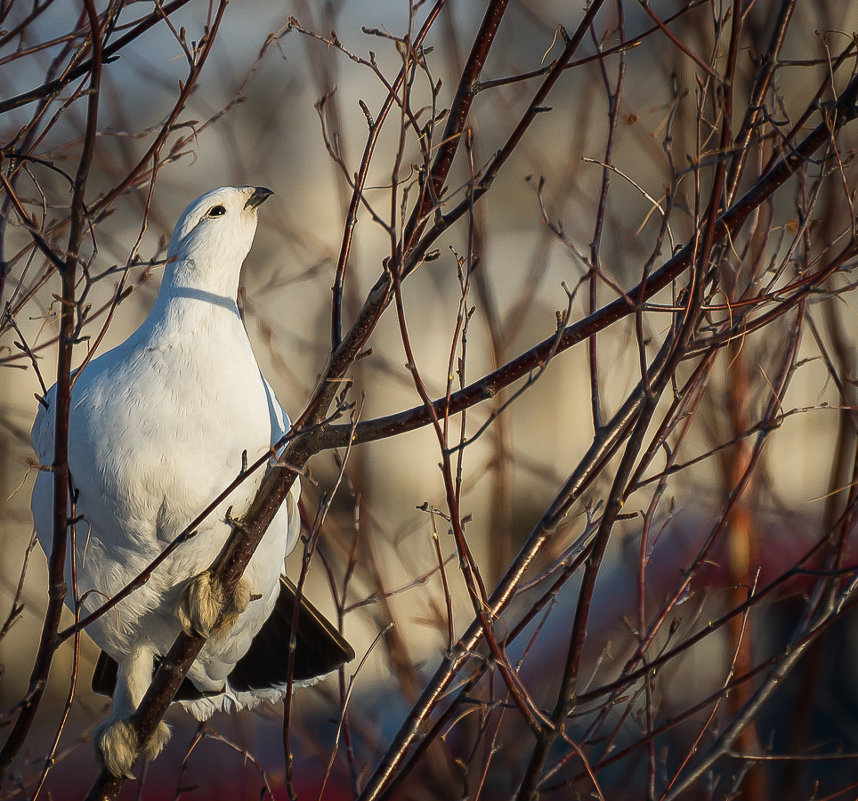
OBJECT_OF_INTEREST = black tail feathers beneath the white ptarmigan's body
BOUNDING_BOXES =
[92,576,355,701]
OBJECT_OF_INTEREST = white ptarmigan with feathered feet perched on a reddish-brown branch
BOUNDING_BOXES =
[32,186,354,775]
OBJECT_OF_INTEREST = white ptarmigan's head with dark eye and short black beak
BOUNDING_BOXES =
[165,186,274,296]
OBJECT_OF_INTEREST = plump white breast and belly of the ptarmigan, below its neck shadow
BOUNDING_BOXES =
[33,299,292,672]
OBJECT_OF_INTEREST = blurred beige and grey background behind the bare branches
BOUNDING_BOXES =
[0,0,858,799]
